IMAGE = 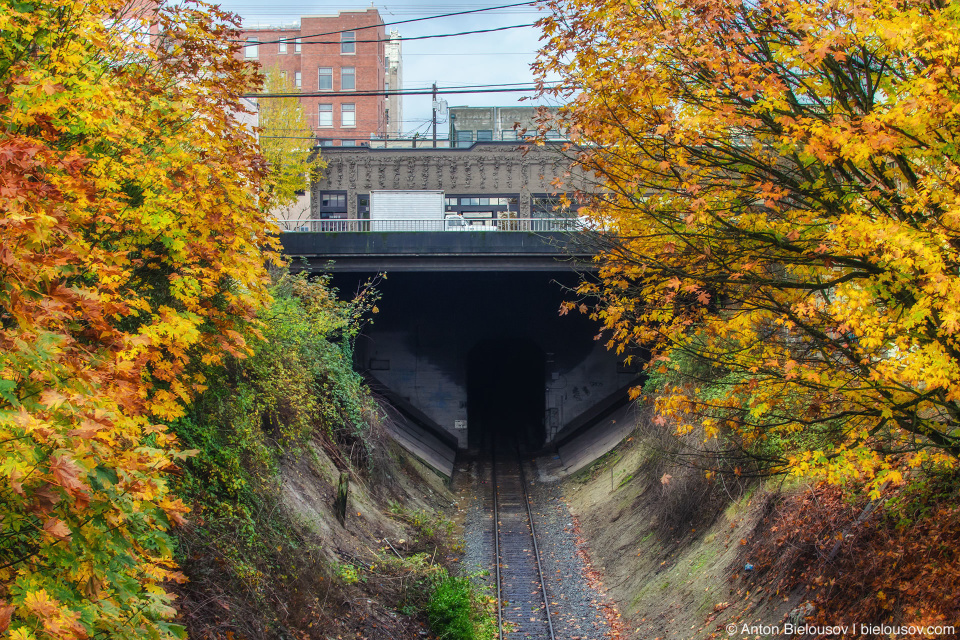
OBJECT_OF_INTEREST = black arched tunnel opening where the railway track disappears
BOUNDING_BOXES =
[467,338,546,451]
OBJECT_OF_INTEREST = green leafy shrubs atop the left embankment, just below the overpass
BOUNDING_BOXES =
[173,274,375,518]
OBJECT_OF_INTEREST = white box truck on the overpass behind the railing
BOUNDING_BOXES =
[370,190,463,231]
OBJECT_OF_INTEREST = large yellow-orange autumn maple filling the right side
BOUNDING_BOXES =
[537,0,960,488]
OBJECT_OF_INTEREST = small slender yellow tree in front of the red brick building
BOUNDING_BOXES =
[257,67,326,225]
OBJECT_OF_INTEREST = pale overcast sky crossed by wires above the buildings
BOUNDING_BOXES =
[210,0,556,137]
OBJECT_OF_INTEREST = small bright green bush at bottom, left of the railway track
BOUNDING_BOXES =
[427,576,497,640]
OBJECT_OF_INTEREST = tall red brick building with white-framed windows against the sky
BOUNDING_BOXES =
[242,8,390,146]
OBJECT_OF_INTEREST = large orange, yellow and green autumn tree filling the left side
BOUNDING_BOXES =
[0,0,274,640]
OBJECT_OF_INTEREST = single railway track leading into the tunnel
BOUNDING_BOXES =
[491,451,554,640]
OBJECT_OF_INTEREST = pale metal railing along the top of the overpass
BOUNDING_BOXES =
[277,217,583,233]
